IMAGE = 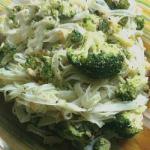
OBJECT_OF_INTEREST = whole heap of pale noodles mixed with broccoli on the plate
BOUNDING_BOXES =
[0,0,149,150]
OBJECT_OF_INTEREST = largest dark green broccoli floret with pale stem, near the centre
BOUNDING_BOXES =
[67,32,124,78]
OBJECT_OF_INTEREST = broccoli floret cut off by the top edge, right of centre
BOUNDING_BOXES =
[105,0,130,9]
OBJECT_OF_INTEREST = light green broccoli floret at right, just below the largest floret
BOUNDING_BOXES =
[116,76,146,101]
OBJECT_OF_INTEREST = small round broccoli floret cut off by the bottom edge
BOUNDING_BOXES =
[93,137,111,150]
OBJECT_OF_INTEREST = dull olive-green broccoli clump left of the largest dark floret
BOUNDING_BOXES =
[24,56,53,82]
